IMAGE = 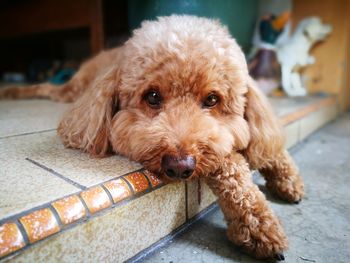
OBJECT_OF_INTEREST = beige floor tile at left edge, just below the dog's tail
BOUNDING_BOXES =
[0,100,69,138]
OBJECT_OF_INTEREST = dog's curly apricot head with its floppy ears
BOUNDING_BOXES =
[59,16,284,182]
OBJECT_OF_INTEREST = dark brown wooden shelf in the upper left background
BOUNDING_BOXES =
[0,0,104,54]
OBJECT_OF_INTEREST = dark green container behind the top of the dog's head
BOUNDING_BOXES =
[128,0,258,52]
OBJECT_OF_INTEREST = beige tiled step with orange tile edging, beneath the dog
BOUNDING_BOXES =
[0,98,336,261]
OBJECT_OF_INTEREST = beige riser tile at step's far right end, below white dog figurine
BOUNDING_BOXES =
[300,105,338,140]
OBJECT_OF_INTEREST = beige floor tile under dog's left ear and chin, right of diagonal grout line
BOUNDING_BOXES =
[25,132,142,187]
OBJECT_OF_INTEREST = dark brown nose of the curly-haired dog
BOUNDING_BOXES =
[162,154,196,179]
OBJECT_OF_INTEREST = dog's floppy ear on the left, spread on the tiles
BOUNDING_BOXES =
[57,68,120,156]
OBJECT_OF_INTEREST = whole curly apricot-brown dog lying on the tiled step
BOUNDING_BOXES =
[1,16,303,259]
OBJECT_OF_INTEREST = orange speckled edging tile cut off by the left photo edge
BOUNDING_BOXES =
[0,222,25,257]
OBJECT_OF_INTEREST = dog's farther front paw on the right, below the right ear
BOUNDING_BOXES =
[266,175,304,204]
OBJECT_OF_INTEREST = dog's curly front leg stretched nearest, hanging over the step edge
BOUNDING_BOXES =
[207,154,287,260]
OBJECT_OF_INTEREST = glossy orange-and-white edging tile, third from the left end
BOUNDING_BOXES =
[52,195,86,225]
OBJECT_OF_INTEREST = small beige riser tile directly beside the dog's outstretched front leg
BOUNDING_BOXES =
[187,179,217,221]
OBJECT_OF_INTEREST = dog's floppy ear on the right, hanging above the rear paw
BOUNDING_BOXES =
[245,77,284,169]
